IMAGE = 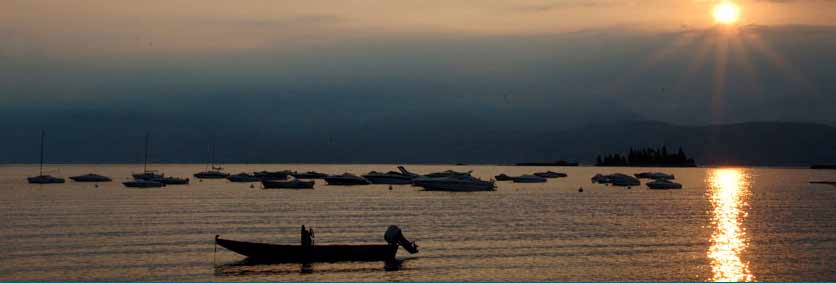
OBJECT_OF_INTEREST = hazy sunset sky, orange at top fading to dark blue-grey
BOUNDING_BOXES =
[0,0,836,163]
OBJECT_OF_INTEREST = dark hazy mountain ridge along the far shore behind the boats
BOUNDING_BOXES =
[0,121,836,167]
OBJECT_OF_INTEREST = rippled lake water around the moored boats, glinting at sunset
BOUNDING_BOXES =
[0,164,836,281]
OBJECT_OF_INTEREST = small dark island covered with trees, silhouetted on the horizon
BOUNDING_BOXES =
[595,146,697,167]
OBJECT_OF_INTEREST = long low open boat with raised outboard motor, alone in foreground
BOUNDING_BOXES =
[215,225,418,263]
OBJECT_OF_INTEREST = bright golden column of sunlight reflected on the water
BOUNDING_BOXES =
[706,169,755,282]
